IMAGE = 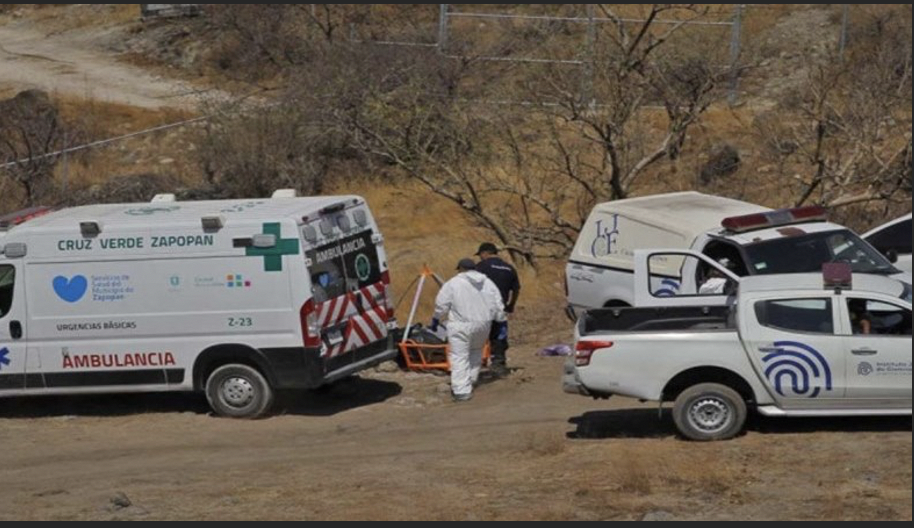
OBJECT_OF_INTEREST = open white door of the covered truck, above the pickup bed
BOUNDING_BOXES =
[635,249,740,308]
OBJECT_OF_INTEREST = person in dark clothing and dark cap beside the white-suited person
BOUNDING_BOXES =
[476,242,520,376]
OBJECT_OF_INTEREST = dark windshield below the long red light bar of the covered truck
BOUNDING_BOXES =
[745,229,898,275]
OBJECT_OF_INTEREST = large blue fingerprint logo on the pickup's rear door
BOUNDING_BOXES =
[762,341,832,398]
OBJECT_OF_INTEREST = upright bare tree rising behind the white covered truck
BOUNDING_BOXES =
[538,4,729,200]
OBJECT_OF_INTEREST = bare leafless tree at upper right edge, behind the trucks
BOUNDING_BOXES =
[760,6,912,208]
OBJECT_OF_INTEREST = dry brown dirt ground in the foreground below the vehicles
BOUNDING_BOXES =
[0,324,911,521]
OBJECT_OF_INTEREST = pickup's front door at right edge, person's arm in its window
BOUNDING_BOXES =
[840,293,911,409]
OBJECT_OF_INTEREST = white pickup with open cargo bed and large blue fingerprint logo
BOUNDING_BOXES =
[563,250,911,441]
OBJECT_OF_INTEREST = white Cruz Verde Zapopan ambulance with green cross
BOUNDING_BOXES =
[0,194,396,417]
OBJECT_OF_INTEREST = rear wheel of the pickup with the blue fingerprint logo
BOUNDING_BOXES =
[673,383,747,442]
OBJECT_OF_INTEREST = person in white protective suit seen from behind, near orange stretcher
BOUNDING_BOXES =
[431,259,506,401]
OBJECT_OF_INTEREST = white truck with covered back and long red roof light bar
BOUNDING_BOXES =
[565,192,911,320]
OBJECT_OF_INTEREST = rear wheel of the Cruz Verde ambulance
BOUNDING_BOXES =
[206,364,274,418]
